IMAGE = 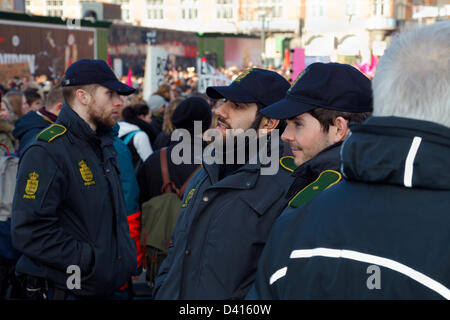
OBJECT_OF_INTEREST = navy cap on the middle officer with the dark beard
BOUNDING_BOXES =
[206,68,289,106]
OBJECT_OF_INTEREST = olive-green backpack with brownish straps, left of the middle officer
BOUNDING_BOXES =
[141,148,200,288]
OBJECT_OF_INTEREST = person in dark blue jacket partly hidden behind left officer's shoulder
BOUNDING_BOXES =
[13,84,64,155]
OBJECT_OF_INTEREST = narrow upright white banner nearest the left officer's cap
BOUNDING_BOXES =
[143,44,168,101]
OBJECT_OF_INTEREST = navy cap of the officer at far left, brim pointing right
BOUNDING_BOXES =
[61,59,136,96]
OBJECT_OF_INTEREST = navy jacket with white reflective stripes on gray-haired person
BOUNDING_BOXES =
[248,117,450,299]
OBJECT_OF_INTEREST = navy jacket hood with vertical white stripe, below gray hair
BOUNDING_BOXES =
[341,117,450,190]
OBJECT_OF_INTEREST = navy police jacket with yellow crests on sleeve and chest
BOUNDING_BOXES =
[12,105,136,296]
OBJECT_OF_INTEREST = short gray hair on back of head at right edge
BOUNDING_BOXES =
[372,20,450,127]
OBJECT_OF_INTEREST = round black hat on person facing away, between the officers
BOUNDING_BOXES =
[172,97,212,132]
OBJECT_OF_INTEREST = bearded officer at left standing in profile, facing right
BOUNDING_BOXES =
[12,59,136,299]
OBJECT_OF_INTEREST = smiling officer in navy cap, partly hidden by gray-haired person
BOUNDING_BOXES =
[248,63,373,299]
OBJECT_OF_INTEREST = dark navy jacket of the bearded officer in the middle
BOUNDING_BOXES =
[154,138,292,299]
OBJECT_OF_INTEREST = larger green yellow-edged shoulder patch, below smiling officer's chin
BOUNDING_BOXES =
[289,170,342,208]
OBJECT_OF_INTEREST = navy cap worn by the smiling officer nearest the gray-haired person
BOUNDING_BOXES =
[261,62,373,119]
